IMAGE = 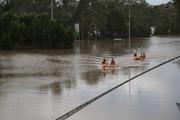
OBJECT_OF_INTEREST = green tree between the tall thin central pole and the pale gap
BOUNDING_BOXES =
[131,0,151,37]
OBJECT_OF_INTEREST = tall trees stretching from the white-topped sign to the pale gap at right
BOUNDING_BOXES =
[77,0,151,38]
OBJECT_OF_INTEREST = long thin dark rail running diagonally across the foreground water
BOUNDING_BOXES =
[55,56,180,120]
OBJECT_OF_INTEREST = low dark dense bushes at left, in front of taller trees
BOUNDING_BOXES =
[0,12,74,49]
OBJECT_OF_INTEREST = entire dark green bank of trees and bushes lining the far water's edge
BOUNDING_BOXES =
[0,0,180,49]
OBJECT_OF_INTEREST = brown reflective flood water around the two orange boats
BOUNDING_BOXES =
[0,37,180,120]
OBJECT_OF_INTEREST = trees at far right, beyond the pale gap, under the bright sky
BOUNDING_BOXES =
[154,2,180,35]
